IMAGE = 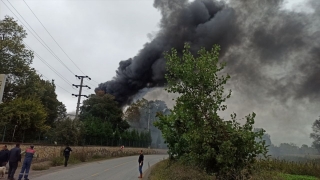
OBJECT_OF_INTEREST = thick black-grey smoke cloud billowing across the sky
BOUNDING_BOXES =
[96,0,320,105]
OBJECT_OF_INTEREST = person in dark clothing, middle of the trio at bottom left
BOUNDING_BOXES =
[8,144,21,180]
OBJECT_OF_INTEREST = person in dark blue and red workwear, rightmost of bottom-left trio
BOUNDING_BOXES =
[18,145,37,180]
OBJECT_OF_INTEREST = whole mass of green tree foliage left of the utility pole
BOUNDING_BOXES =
[0,16,66,142]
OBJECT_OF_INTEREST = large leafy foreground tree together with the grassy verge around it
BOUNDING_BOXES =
[149,44,320,180]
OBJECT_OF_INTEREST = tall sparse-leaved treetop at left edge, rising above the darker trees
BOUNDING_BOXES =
[0,16,36,102]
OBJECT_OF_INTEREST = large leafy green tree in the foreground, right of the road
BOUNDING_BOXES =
[155,44,267,179]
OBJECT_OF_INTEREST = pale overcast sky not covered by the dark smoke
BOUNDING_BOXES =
[0,0,317,145]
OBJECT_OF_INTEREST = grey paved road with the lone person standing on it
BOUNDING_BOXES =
[31,155,167,180]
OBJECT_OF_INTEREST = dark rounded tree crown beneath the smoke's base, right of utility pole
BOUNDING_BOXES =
[80,94,130,132]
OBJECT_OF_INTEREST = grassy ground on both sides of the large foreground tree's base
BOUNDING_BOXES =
[148,157,320,180]
